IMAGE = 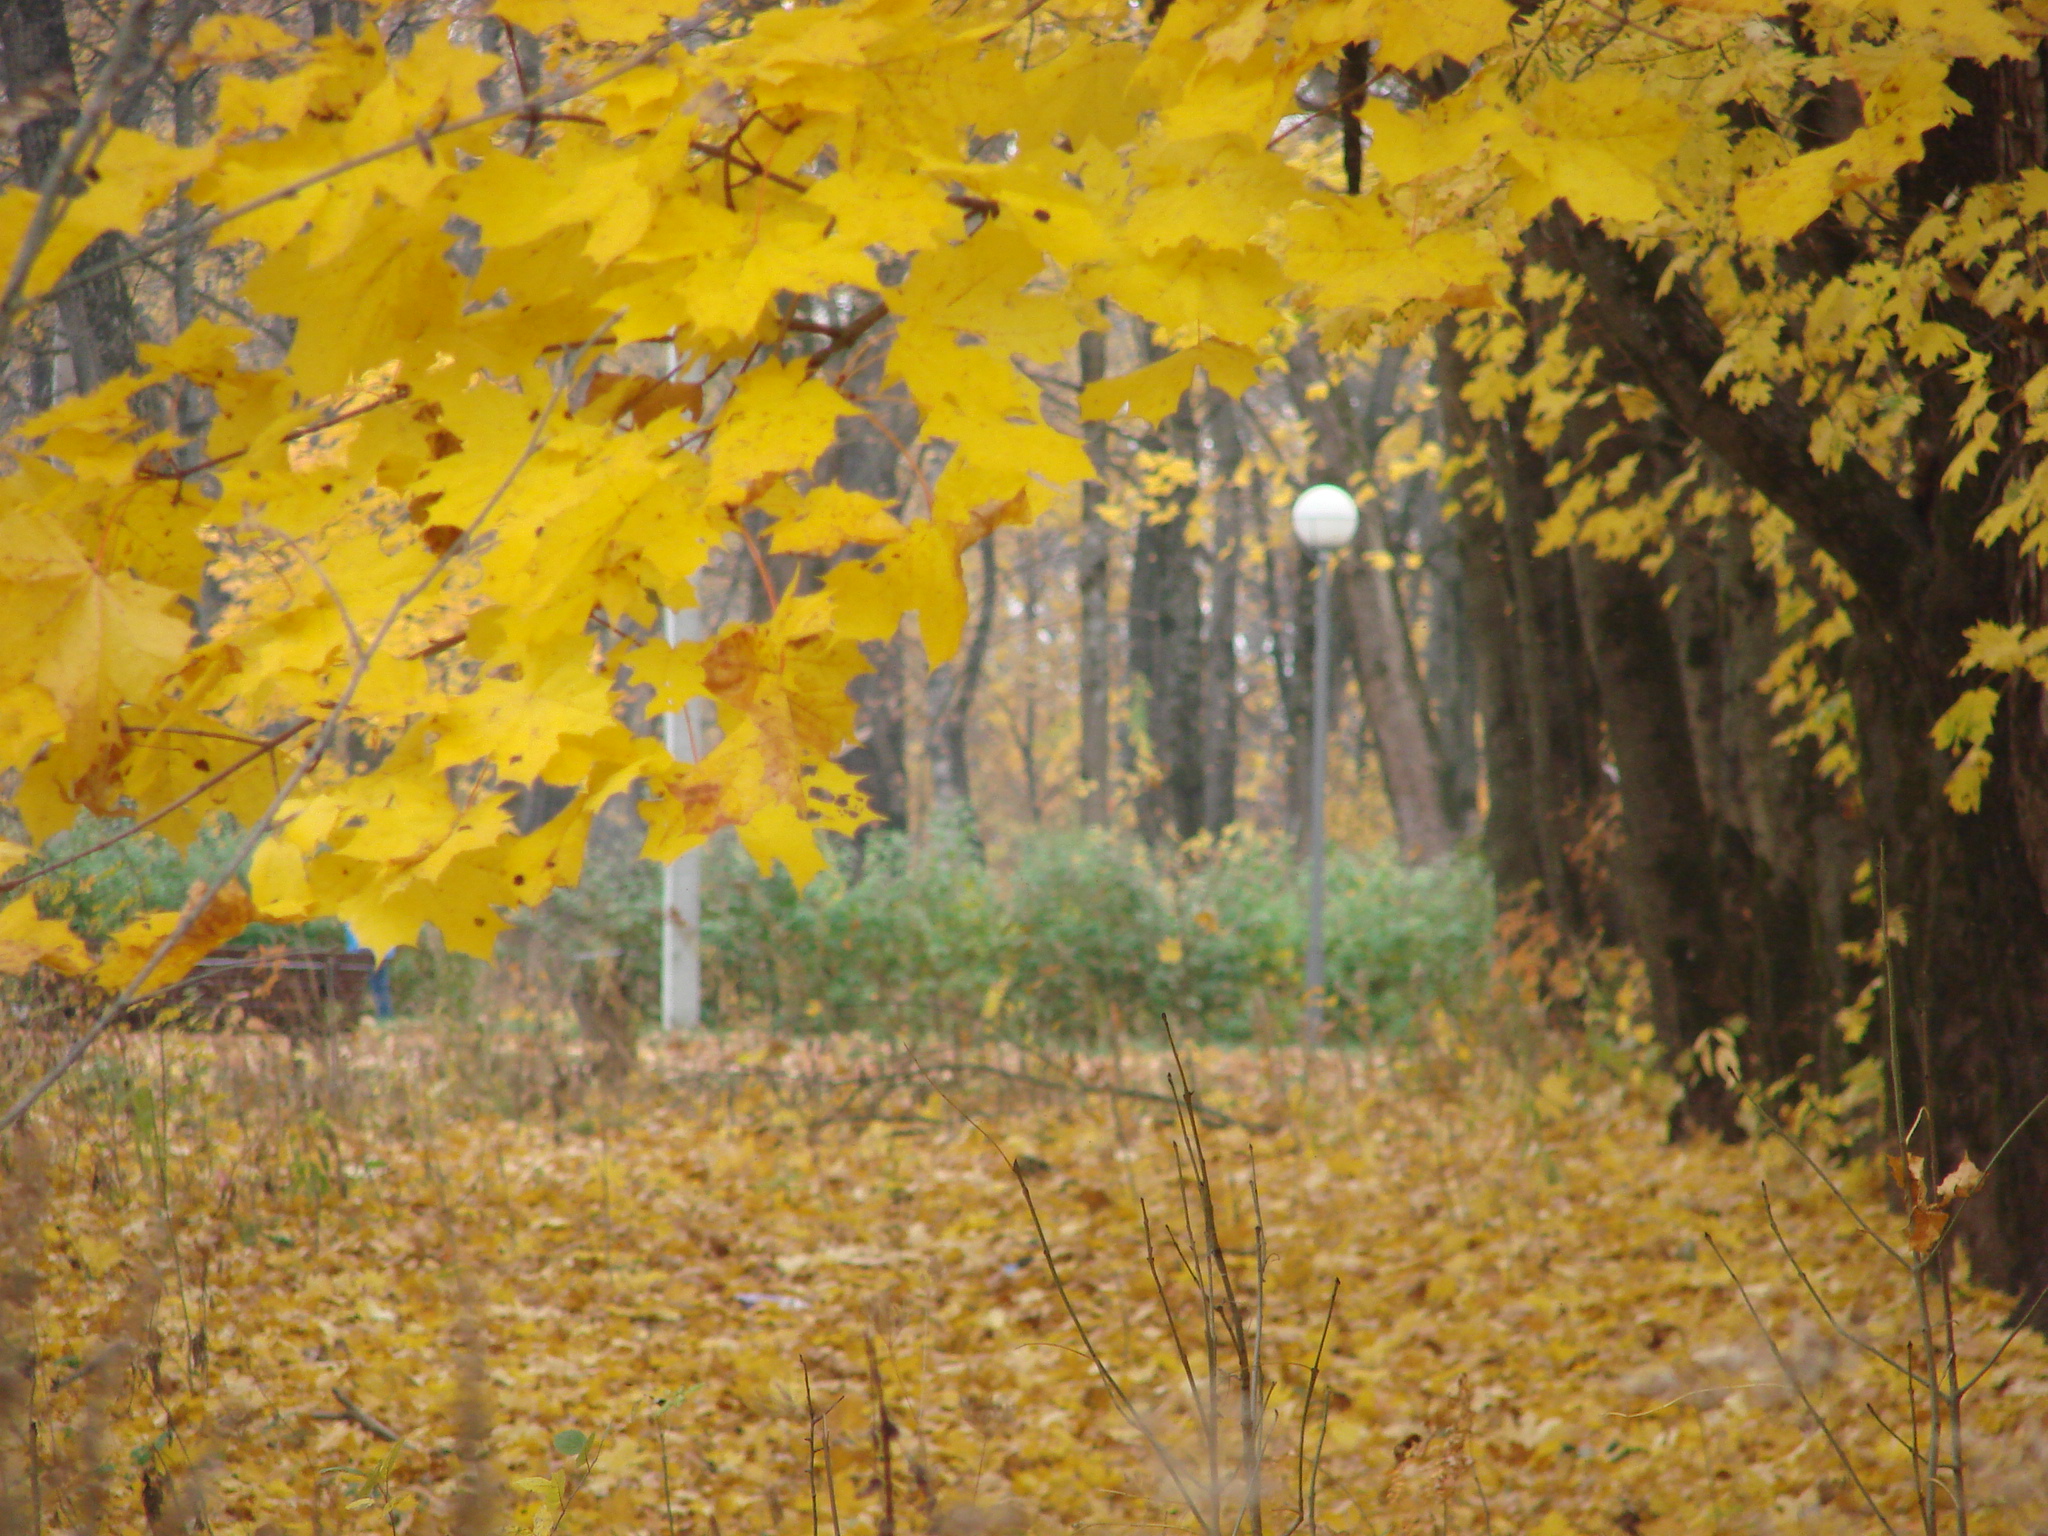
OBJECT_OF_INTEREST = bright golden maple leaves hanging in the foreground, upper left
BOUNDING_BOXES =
[0,0,2011,974]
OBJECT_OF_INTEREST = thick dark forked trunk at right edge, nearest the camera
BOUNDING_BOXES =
[1538,171,2048,1296]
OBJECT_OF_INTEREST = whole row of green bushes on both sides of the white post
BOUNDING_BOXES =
[12,806,1491,1042]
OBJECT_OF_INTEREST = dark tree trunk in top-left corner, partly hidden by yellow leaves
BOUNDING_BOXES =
[0,0,137,393]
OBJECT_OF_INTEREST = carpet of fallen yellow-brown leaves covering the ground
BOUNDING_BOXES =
[16,1036,2048,1536]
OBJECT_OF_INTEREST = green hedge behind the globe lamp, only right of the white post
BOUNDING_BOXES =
[705,819,1491,1040]
